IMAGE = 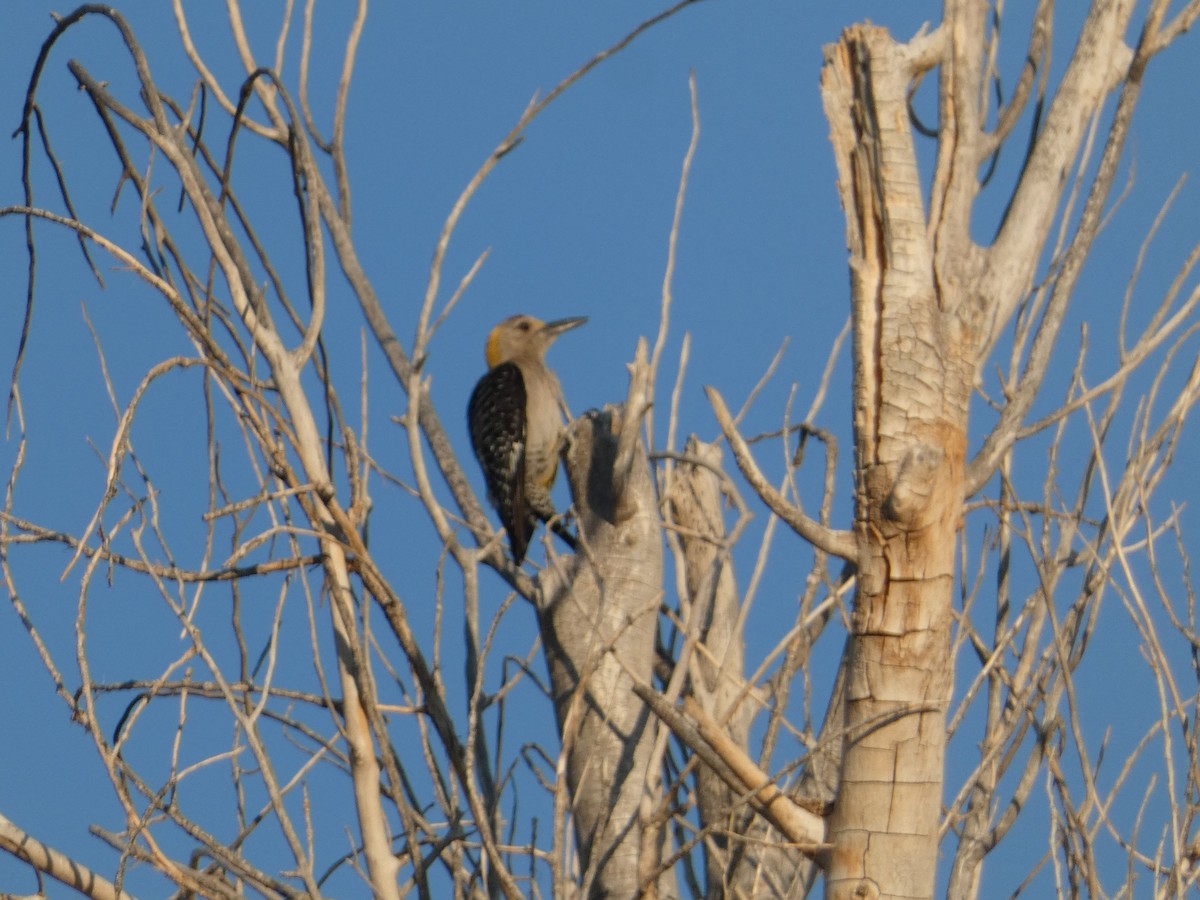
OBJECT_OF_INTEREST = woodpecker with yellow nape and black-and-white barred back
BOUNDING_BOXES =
[467,316,587,565]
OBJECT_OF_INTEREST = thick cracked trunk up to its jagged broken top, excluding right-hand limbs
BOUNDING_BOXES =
[822,26,974,898]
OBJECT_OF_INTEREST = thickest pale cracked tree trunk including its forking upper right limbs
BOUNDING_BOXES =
[821,0,1137,898]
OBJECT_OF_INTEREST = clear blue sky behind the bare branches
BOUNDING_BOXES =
[0,0,1200,895]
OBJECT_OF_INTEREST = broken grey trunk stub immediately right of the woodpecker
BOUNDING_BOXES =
[538,364,662,896]
